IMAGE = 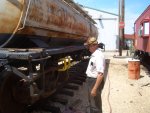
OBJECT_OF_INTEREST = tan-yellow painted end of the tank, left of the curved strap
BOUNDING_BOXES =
[0,0,23,33]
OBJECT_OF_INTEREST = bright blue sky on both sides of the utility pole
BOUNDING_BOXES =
[74,0,150,34]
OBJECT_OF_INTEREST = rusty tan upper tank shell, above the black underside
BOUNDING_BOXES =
[0,0,97,46]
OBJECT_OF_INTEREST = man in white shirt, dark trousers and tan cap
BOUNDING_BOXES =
[84,37,105,113]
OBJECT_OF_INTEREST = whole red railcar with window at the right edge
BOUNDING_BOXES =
[134,5,150,63]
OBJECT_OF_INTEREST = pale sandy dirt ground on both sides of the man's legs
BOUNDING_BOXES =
[61,52,150,113]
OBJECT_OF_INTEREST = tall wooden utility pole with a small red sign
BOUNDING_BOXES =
[119,0,125,56]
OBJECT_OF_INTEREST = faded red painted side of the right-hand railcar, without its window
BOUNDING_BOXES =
[135,5,150,52]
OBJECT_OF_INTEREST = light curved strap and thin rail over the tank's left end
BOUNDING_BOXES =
[0,0,31,47]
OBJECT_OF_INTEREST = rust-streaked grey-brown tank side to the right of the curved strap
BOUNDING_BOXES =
[23,0,94,36]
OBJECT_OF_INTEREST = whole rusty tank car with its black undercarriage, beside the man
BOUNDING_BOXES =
[0,0,98,113]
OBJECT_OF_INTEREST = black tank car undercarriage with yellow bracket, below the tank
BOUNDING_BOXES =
[0,46,88,113]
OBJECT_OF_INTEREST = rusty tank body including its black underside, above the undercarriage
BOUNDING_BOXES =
[0,0,97,47]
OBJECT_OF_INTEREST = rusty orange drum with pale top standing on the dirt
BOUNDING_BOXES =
[128,59,140,79]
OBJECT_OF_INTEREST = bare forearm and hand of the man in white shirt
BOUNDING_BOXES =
[91,73,103,96]
